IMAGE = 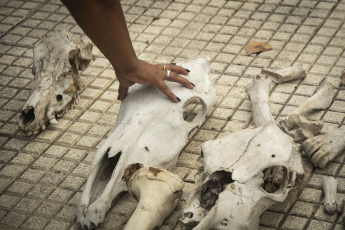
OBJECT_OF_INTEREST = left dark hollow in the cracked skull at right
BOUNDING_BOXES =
[199,170,234,211]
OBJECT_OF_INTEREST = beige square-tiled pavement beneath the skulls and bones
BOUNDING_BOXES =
[0,0,345,230]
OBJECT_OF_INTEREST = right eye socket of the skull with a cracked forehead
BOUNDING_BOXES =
[261,166,288,193]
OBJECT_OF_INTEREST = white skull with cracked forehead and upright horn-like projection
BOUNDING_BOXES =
[182,76,304,230]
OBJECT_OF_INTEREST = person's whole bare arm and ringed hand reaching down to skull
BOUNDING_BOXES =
[61,0,194,102]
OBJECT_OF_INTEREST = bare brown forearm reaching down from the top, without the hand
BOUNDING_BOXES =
[61,0,138,73]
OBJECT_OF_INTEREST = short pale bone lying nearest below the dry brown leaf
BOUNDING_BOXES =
[261,64,306,83]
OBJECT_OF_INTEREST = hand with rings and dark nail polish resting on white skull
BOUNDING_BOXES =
[115,60,194,102]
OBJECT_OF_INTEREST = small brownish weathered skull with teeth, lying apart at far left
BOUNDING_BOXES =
[19,31,92,135]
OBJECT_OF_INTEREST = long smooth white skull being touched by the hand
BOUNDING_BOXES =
[76,58,216,228]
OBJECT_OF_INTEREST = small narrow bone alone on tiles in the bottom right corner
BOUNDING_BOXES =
[322,176,343,215]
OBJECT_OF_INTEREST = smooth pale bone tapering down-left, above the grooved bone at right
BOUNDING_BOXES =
[294,80,335,115]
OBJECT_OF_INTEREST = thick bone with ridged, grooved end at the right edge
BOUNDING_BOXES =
[302,126,345,169]
